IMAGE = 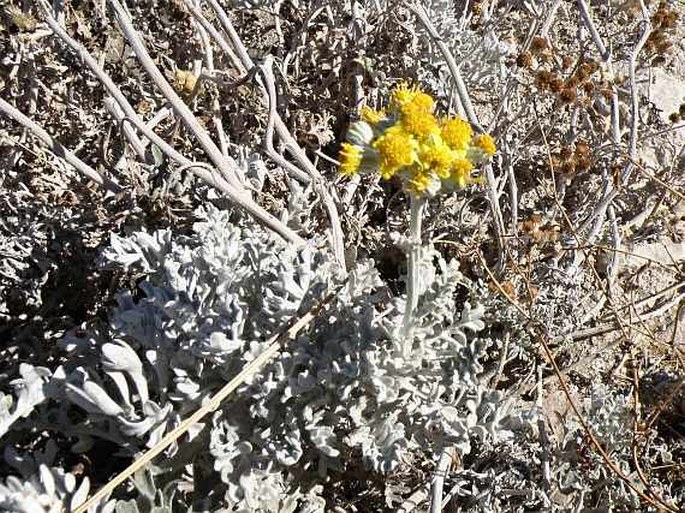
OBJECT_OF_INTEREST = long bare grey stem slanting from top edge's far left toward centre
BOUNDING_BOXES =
[38,0,305,246]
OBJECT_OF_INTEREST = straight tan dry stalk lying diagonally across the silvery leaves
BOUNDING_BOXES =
[74,282,346,513]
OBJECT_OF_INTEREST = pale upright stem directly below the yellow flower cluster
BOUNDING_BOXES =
[402,194,425,358]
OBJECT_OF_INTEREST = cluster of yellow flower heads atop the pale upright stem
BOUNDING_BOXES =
[340,84,497,195]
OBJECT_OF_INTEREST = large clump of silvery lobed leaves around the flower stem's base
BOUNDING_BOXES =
[0,202,507,513]
